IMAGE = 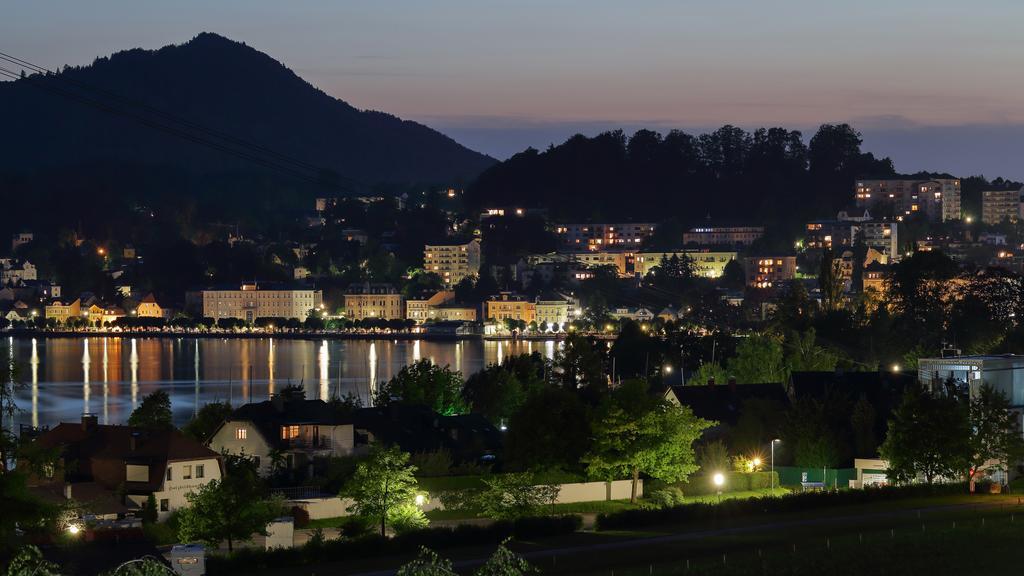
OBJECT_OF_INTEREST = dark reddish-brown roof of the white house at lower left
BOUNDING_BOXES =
[36,422,220,490]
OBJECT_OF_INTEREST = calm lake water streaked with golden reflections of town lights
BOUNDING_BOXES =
[0,336,560,429]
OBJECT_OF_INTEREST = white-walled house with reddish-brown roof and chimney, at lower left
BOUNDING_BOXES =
[30,415,221,520]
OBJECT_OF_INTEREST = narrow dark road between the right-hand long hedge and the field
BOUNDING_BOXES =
[350,502,1017,576]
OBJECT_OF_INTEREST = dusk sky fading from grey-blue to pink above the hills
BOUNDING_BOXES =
[8,0,1024,178]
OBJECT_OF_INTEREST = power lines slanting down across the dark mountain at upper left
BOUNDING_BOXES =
[0,52,358,190]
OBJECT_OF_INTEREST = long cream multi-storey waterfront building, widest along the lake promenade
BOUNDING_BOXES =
[200,283,324,324]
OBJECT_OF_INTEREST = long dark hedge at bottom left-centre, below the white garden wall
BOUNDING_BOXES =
[206,515,583,574]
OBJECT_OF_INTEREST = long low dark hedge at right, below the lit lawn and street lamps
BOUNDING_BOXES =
[597,484,967,530]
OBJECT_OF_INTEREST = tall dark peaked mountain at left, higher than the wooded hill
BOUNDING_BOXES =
[0,33,494,188]
